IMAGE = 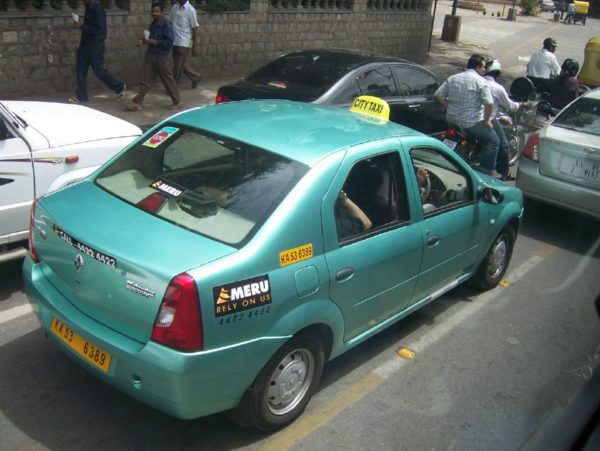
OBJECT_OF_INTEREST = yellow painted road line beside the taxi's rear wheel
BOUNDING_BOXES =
[259,373,382,451]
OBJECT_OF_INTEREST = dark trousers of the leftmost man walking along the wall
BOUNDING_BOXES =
[75,42,125,102]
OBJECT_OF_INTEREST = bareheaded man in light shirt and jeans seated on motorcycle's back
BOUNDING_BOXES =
[433,55,500,173]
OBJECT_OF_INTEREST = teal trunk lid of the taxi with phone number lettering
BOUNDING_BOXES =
[36,181,235,342]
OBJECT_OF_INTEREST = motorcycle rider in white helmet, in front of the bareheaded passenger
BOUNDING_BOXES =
[484,58,526,181]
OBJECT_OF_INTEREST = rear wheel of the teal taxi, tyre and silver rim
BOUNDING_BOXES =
[232,334,325,432]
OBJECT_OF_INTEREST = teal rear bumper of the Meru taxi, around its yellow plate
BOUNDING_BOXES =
[23,256,287,419]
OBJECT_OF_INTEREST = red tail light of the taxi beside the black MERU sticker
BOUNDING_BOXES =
[152,273,204,352]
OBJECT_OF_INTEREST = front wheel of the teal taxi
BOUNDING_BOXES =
[473,227,515,290]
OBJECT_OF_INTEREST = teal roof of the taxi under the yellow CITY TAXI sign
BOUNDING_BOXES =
[171,100,423,166]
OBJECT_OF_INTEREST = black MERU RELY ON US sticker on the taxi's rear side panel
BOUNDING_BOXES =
[213,274,271,318]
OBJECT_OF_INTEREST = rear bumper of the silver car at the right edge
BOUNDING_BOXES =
[516,157,600,219]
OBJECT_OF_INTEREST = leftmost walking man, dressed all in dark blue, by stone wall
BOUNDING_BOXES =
[69,0,125,103]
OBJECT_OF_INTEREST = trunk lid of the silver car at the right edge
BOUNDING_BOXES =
[539,126,600,189]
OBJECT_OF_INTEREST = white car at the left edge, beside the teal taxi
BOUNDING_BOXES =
[0,101,142,263]
